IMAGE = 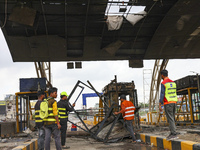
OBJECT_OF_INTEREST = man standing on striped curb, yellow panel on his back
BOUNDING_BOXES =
[159,70,178,140]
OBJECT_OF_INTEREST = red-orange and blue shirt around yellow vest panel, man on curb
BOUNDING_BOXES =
[159,77,176,105]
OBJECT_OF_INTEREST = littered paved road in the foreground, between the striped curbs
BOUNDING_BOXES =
[51,137,163,150]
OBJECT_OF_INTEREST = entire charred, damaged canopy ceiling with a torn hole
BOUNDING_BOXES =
[0,0,200,67]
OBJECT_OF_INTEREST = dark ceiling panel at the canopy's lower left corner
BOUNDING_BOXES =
[8,35,67,61]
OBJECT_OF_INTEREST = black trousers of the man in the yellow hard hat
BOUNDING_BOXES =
[60,119,67,146]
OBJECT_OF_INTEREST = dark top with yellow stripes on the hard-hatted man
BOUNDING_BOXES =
[58,99,74,121]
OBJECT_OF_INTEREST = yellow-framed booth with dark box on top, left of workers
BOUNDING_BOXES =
[15,78,47,133]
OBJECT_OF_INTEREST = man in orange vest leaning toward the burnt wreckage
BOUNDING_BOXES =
[114,94,137,143]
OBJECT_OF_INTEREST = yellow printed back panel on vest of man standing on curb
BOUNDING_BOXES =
[164,82,178,102]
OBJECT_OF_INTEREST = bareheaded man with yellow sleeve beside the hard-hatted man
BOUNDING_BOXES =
[44,87,62,150]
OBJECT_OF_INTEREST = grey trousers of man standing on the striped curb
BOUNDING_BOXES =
[164,103,177,135]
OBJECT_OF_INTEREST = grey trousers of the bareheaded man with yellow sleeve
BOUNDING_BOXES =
[45,124,62,150]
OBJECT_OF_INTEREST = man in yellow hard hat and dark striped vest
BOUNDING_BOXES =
[58,91,75,149]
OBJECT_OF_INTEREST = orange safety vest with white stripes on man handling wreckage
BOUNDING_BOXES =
[122,100,135,120]
